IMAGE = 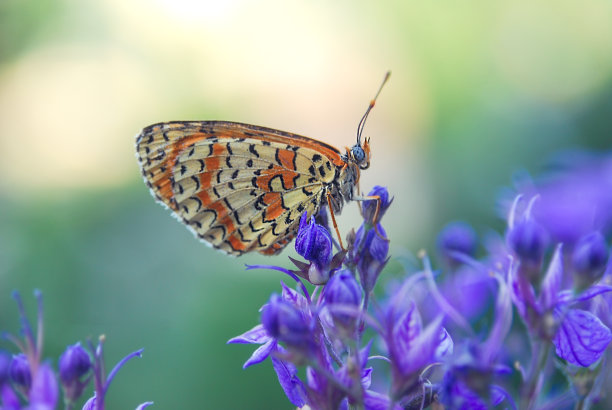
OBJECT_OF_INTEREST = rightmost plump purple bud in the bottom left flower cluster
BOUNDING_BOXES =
[58,342,91,402]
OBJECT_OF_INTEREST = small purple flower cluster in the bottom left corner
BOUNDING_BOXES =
[0,291,153,410]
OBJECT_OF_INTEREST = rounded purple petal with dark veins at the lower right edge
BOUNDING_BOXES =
[553,309,612,367]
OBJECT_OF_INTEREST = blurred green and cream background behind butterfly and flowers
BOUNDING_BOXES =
[0,0,612,409]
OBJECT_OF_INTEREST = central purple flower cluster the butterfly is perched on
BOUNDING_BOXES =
[229,186,453,409]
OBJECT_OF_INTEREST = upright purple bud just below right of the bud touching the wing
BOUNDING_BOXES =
[323,270,361,331]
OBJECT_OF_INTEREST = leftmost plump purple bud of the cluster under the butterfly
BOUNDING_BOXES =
[261,294,311,347]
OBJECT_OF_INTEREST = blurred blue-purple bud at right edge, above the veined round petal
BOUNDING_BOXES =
[572,232,609,289]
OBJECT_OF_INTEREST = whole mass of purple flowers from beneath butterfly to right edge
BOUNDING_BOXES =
[229,153,612,410]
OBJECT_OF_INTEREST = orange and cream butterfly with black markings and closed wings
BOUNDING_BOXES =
[136,73,390,256]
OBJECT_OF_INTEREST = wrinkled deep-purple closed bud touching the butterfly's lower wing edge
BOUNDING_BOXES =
[295,214,332,270]
